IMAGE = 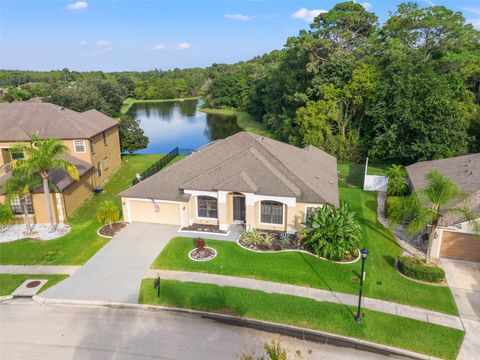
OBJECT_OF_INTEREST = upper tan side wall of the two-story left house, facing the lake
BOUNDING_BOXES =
[89,126,122,185]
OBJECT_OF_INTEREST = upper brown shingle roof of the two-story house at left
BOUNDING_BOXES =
[0,102,118,141]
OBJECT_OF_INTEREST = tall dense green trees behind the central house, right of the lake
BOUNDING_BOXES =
[204,2,480,163]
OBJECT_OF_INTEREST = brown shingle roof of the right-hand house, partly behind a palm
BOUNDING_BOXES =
[406,153,480,225]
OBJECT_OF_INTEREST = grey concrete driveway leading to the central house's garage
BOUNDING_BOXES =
[42,223,178,303]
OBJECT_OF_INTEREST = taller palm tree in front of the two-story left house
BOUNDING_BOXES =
[13,135,79,232]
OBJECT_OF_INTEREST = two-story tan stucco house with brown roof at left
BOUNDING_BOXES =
[0,102,121,223]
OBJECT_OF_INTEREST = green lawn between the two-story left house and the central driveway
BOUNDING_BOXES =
[0,155,163,265]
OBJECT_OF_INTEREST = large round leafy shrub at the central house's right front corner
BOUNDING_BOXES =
[302,204,361,261]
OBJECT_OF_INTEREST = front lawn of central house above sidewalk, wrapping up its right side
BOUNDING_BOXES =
[152,188,458,315]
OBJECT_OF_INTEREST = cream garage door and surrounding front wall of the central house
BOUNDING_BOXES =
[122,199,183,225]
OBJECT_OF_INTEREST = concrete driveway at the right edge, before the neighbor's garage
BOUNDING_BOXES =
[441,259,480,360]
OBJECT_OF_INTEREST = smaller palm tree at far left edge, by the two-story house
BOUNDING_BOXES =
[4,171,42,235]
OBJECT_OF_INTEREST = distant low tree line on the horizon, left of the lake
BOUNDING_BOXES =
[0,69,207,116]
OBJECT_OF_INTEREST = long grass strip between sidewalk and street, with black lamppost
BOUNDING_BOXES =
[139,279,464,359]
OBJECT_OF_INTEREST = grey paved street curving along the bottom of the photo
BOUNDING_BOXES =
[0,300,385,360]
